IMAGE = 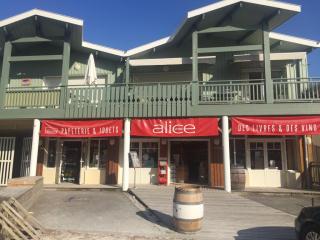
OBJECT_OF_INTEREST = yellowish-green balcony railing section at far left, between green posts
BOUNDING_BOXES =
[4,87,60,109]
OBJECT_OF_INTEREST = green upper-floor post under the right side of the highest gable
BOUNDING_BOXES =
[262,23,273,103]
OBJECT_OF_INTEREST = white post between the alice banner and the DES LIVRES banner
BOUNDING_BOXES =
[222,116,231,192]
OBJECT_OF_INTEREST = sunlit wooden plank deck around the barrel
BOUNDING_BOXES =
[132,186,295,240]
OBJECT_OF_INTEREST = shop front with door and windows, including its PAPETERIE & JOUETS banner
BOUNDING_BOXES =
[40,120,122,184]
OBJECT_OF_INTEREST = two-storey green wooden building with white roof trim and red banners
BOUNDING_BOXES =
[0,0,320,191]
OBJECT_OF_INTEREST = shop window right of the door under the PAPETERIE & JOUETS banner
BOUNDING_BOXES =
[89,140,108,168]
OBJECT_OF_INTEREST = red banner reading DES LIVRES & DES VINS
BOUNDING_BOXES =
[232,116,320,136]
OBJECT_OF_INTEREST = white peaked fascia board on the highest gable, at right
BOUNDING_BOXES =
[188,0,301,18]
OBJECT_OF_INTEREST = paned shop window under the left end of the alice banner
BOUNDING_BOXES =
[130,142,159,168]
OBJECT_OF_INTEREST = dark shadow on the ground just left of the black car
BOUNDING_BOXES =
[234,227,296,240]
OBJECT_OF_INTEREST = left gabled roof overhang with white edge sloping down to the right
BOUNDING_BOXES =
[0,9,125,58]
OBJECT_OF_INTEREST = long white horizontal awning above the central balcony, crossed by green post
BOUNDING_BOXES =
[130,56,216,66]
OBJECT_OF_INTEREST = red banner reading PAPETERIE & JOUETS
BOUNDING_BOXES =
[40,120,122,138]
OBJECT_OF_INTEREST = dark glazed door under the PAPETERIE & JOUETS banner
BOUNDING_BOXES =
[60,141,81,183]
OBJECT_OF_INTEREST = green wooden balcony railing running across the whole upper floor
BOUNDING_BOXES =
[3,78,320,118]
